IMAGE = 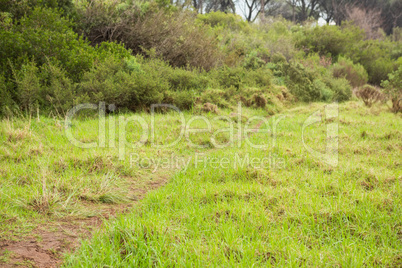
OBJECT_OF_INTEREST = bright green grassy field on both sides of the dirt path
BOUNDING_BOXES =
[0,102,402,267]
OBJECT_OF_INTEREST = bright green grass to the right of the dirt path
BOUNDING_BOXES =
[61,102,402,267]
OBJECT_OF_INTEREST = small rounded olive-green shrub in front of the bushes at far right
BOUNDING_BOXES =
[332,57,368,88]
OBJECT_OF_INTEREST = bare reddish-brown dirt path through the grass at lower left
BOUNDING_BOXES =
[0,174,168,268]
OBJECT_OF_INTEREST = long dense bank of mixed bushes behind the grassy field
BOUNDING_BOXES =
[0,0,396,115]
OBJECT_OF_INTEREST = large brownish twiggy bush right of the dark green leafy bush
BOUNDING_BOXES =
[79,1,221,70]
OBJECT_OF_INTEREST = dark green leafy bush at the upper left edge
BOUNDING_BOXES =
[0,8,97,82]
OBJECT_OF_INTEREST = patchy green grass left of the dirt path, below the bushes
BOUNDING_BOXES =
[0,105,264,240]
